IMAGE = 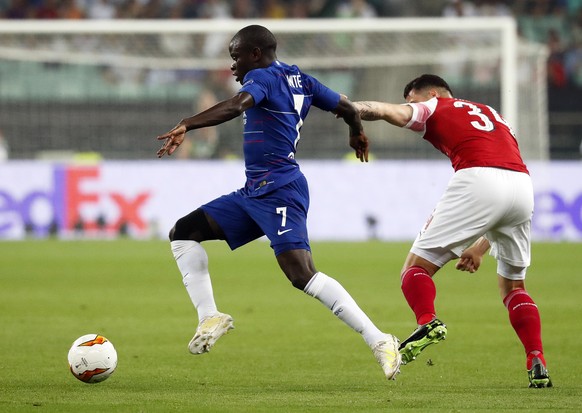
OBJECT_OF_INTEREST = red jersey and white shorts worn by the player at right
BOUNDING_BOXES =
[405,98,534,279]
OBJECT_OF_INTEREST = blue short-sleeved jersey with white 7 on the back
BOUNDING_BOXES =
[240,61,340,197]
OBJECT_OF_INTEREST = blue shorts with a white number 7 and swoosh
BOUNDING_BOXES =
[201,176,311,255]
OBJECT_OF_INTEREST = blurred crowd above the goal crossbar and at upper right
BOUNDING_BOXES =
[0,0,582,88]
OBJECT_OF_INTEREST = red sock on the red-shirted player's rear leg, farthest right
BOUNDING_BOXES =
[503,289,545,370]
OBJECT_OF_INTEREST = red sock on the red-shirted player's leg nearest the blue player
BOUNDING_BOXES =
[401,267,436,324]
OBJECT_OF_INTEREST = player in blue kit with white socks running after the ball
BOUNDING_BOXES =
[158,25,401,379]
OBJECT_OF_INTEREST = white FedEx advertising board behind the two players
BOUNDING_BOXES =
[0,160,582,241]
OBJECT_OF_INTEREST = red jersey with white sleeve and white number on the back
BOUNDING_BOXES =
[405,98,529,173]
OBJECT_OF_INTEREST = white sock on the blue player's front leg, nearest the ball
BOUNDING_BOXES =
[175,241,218,321]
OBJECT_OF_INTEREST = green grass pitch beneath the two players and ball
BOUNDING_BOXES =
[0,240,582,412]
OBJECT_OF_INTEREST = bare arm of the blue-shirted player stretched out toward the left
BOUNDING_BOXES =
[157,92,254,158]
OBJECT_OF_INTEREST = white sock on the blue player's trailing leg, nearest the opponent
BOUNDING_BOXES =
[305,272,385,347]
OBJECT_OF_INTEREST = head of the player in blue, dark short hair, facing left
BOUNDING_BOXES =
[228,24,277,83]
